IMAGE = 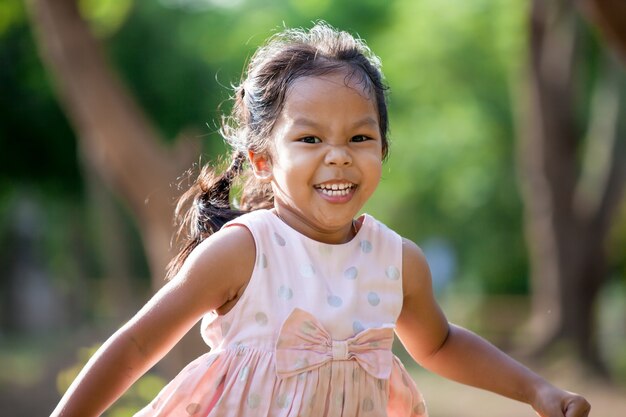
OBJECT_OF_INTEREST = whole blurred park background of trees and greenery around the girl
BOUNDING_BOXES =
[0,0,626,417]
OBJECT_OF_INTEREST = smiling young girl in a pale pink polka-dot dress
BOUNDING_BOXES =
[53,24,590,417]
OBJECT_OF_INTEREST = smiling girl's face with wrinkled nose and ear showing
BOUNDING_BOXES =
[251,72,382,243]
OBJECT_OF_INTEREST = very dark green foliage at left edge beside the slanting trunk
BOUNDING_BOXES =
[0,18,81,198]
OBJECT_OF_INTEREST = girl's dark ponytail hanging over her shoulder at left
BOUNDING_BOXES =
[166,152,249,279]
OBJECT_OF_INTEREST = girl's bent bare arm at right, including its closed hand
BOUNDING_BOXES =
[397,240,590,417]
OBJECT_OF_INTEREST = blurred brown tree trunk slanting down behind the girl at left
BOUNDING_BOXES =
[28,0,200,373]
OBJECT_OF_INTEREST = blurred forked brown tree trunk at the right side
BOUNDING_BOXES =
[519,0,626,371]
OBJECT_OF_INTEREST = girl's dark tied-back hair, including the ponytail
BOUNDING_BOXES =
[167,22,389,278]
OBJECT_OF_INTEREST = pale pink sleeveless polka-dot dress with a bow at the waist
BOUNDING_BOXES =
[136,210,427,417]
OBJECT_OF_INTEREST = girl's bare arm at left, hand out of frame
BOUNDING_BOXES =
[52,227,255,417]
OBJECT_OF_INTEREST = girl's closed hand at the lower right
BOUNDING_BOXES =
[532,384,591,417]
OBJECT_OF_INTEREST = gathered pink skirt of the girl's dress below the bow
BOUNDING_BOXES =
[136,347,427,417]
